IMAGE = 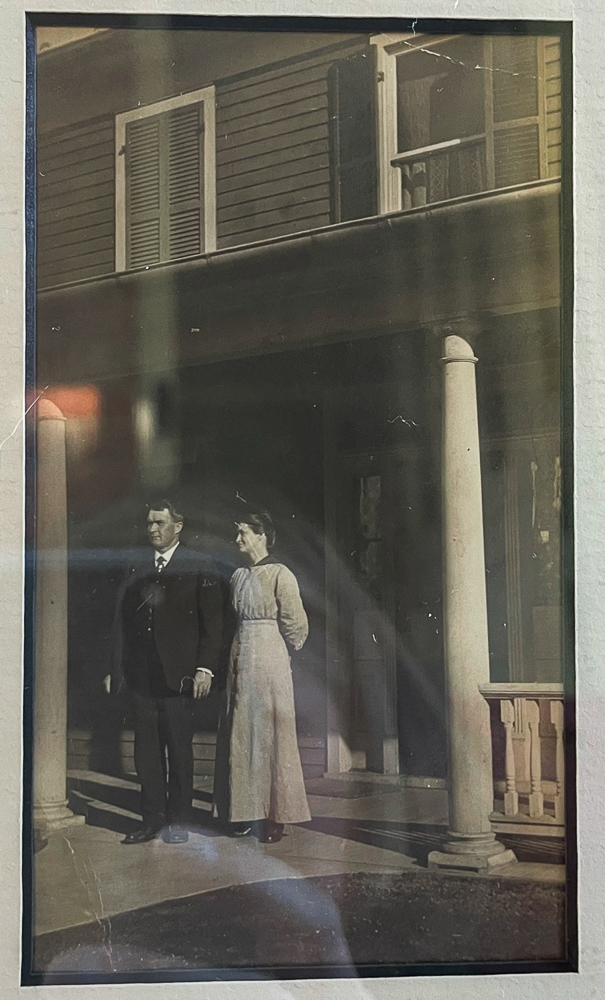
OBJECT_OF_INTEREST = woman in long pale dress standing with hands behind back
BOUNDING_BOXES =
[214,514,311,843]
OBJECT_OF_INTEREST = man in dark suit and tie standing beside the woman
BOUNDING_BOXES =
[107,500,224,844]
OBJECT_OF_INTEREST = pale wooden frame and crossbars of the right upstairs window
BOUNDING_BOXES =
[370,33,548,215]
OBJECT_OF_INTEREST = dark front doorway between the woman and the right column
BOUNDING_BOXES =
[326,447,445,777]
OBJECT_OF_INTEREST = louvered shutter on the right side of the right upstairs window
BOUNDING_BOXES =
[492,36,540,188]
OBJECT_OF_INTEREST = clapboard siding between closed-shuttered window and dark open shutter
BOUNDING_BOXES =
[216,41,360,247]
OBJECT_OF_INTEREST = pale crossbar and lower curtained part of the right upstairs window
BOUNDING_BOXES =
[391,135,487,209]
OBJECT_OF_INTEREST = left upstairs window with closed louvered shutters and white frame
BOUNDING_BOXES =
[116,87,216,271]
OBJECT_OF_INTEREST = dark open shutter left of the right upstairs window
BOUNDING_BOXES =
[328,47,377,222]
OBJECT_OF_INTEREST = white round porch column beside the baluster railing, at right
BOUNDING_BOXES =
[428,329,515,871]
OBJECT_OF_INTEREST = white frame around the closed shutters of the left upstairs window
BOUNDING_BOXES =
[115,85,216,272]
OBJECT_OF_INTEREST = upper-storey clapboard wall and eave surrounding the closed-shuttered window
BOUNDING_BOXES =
[37,32,364,288]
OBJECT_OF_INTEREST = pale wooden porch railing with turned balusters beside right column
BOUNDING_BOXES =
[480,684,565,837]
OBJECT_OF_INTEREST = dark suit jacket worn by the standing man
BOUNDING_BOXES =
[112,544,226,692]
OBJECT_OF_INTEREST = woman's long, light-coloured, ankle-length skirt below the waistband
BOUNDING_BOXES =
[214,619,311,823]
